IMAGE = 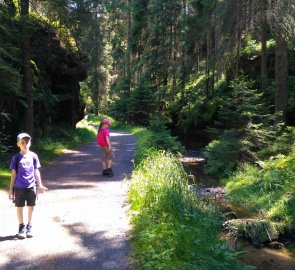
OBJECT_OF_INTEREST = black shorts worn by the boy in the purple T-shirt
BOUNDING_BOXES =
[14,187,37,207]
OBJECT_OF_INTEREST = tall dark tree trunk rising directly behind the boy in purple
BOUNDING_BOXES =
[21,0,34,136]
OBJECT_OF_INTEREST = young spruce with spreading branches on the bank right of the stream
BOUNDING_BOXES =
[205,75,279,176]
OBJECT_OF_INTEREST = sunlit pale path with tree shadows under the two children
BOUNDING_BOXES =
[0,130,136,270]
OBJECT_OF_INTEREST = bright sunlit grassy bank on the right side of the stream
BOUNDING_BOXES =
[226,152,295,231]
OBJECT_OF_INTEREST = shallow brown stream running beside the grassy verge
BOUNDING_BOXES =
[181,151,295,270]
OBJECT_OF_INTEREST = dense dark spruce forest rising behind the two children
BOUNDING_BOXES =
[0,0,295,167]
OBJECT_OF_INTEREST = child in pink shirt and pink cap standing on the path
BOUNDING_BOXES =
[96,119,114,176]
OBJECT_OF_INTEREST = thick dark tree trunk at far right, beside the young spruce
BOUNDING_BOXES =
[275,33,288,123]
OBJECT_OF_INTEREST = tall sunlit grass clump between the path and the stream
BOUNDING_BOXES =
[129,150,243,270]
